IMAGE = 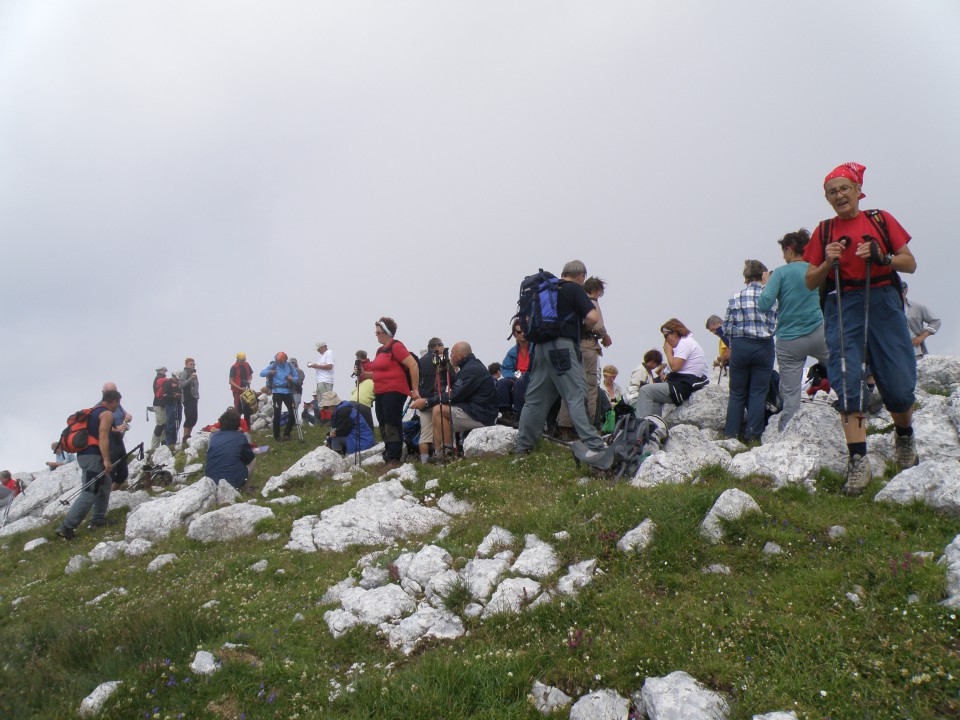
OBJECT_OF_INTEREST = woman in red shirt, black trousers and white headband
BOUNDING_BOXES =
[363,317,420,468]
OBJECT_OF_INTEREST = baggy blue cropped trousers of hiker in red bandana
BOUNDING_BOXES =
[823,285,917,413]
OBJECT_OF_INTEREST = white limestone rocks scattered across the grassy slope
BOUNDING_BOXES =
[0,356,960,720]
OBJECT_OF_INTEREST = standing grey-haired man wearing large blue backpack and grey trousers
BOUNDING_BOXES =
[516,260,606,463]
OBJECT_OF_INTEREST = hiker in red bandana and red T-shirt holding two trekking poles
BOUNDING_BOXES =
[803,163,918,495]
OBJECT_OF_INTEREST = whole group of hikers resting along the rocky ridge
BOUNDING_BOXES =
[33,163,940,537]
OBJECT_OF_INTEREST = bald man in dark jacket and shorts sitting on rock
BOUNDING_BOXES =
[410,340,497,457]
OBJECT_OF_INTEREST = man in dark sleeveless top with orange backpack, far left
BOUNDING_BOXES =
[55,390,120,540]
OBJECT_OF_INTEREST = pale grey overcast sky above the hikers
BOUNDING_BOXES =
[0,0,960,471]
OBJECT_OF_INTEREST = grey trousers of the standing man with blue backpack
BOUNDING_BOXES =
[517,338,606,452]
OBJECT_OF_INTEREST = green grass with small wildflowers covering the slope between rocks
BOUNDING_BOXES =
[0,428,960,720]
